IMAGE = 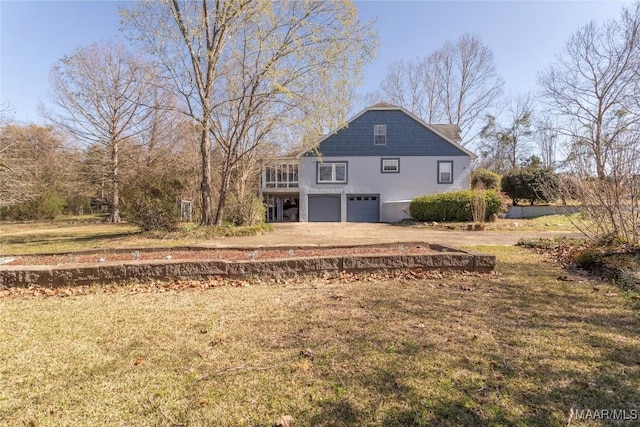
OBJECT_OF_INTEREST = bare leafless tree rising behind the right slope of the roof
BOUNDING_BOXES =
[381,34,503,144]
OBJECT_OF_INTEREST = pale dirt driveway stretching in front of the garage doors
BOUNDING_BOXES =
[202,222,579,247]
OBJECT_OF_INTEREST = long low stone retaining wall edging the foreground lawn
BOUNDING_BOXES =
[0,247,496,287]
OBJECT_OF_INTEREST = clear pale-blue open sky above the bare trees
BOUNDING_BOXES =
[0,0,631,123]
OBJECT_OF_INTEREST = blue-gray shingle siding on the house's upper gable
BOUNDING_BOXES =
[306,110,467,157]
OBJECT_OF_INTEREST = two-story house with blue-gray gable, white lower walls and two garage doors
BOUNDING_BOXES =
[261,103,476,222]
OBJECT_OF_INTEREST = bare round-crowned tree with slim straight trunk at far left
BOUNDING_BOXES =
[43,41,153,222]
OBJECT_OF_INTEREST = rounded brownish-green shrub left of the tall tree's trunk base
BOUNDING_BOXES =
[120,177,182,231]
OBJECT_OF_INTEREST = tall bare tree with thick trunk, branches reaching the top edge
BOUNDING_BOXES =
[122,0,250,225]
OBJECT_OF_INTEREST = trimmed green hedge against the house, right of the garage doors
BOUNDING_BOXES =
[409,190,502,222]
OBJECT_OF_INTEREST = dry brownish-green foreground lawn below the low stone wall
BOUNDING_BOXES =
[0,247,640,426]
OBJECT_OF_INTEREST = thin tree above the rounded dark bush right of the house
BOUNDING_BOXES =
[480,95,533,173]
